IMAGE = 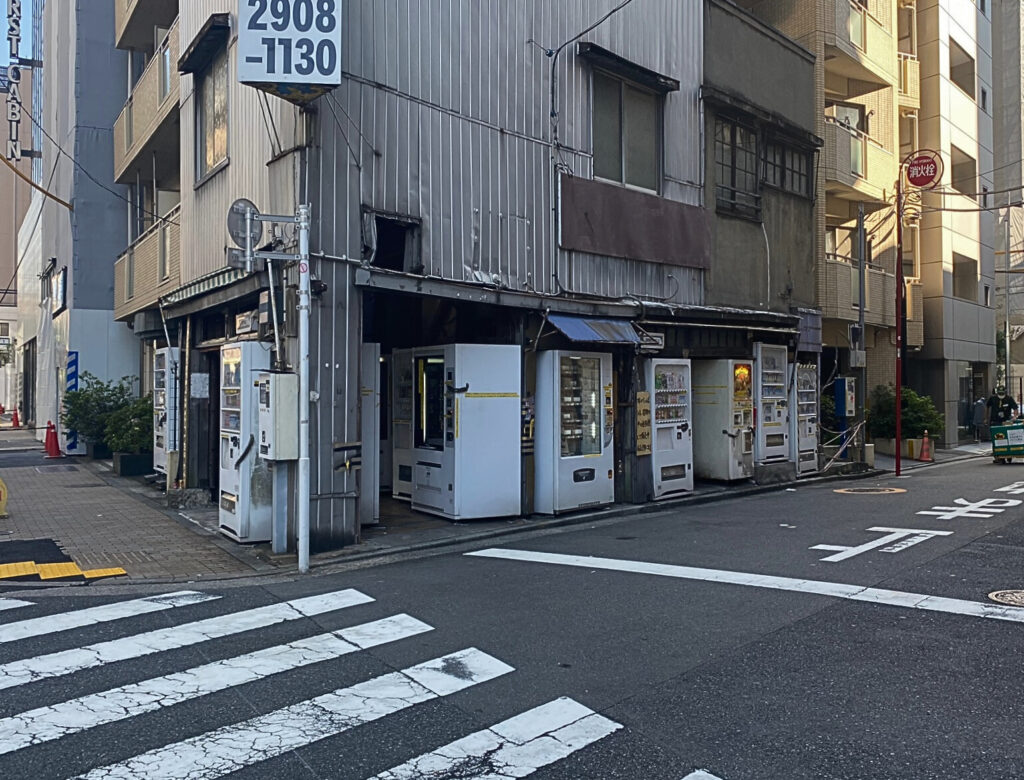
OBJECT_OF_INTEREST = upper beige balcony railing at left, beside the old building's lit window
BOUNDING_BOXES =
[114,20,179,179]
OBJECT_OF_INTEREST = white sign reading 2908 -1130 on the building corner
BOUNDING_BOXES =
[239,0,342,85]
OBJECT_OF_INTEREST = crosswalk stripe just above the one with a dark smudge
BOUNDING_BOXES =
[0,614,432,754]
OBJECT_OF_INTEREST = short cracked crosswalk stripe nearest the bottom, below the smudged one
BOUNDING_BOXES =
[372,698,623,780]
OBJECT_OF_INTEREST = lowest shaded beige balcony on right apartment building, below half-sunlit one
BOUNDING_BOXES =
[821,253,896,328]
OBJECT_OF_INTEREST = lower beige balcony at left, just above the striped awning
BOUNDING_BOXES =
[114,206,181,320]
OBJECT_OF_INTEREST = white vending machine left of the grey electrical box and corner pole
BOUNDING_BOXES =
[219,341,273,543]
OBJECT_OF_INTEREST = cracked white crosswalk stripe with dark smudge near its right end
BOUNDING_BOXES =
[75,648,514,780]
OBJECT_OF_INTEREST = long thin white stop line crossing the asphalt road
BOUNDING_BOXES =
[466,549,1024,623]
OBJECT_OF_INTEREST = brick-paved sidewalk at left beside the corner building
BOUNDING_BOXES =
[0,429,266,581]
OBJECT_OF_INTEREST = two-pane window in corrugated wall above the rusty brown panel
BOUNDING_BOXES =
[593,71,662,191]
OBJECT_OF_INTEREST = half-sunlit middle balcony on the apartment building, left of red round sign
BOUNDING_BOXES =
[822,117,896,205]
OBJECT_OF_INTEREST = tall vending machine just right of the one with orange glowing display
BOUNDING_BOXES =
[754,343,792,463]
